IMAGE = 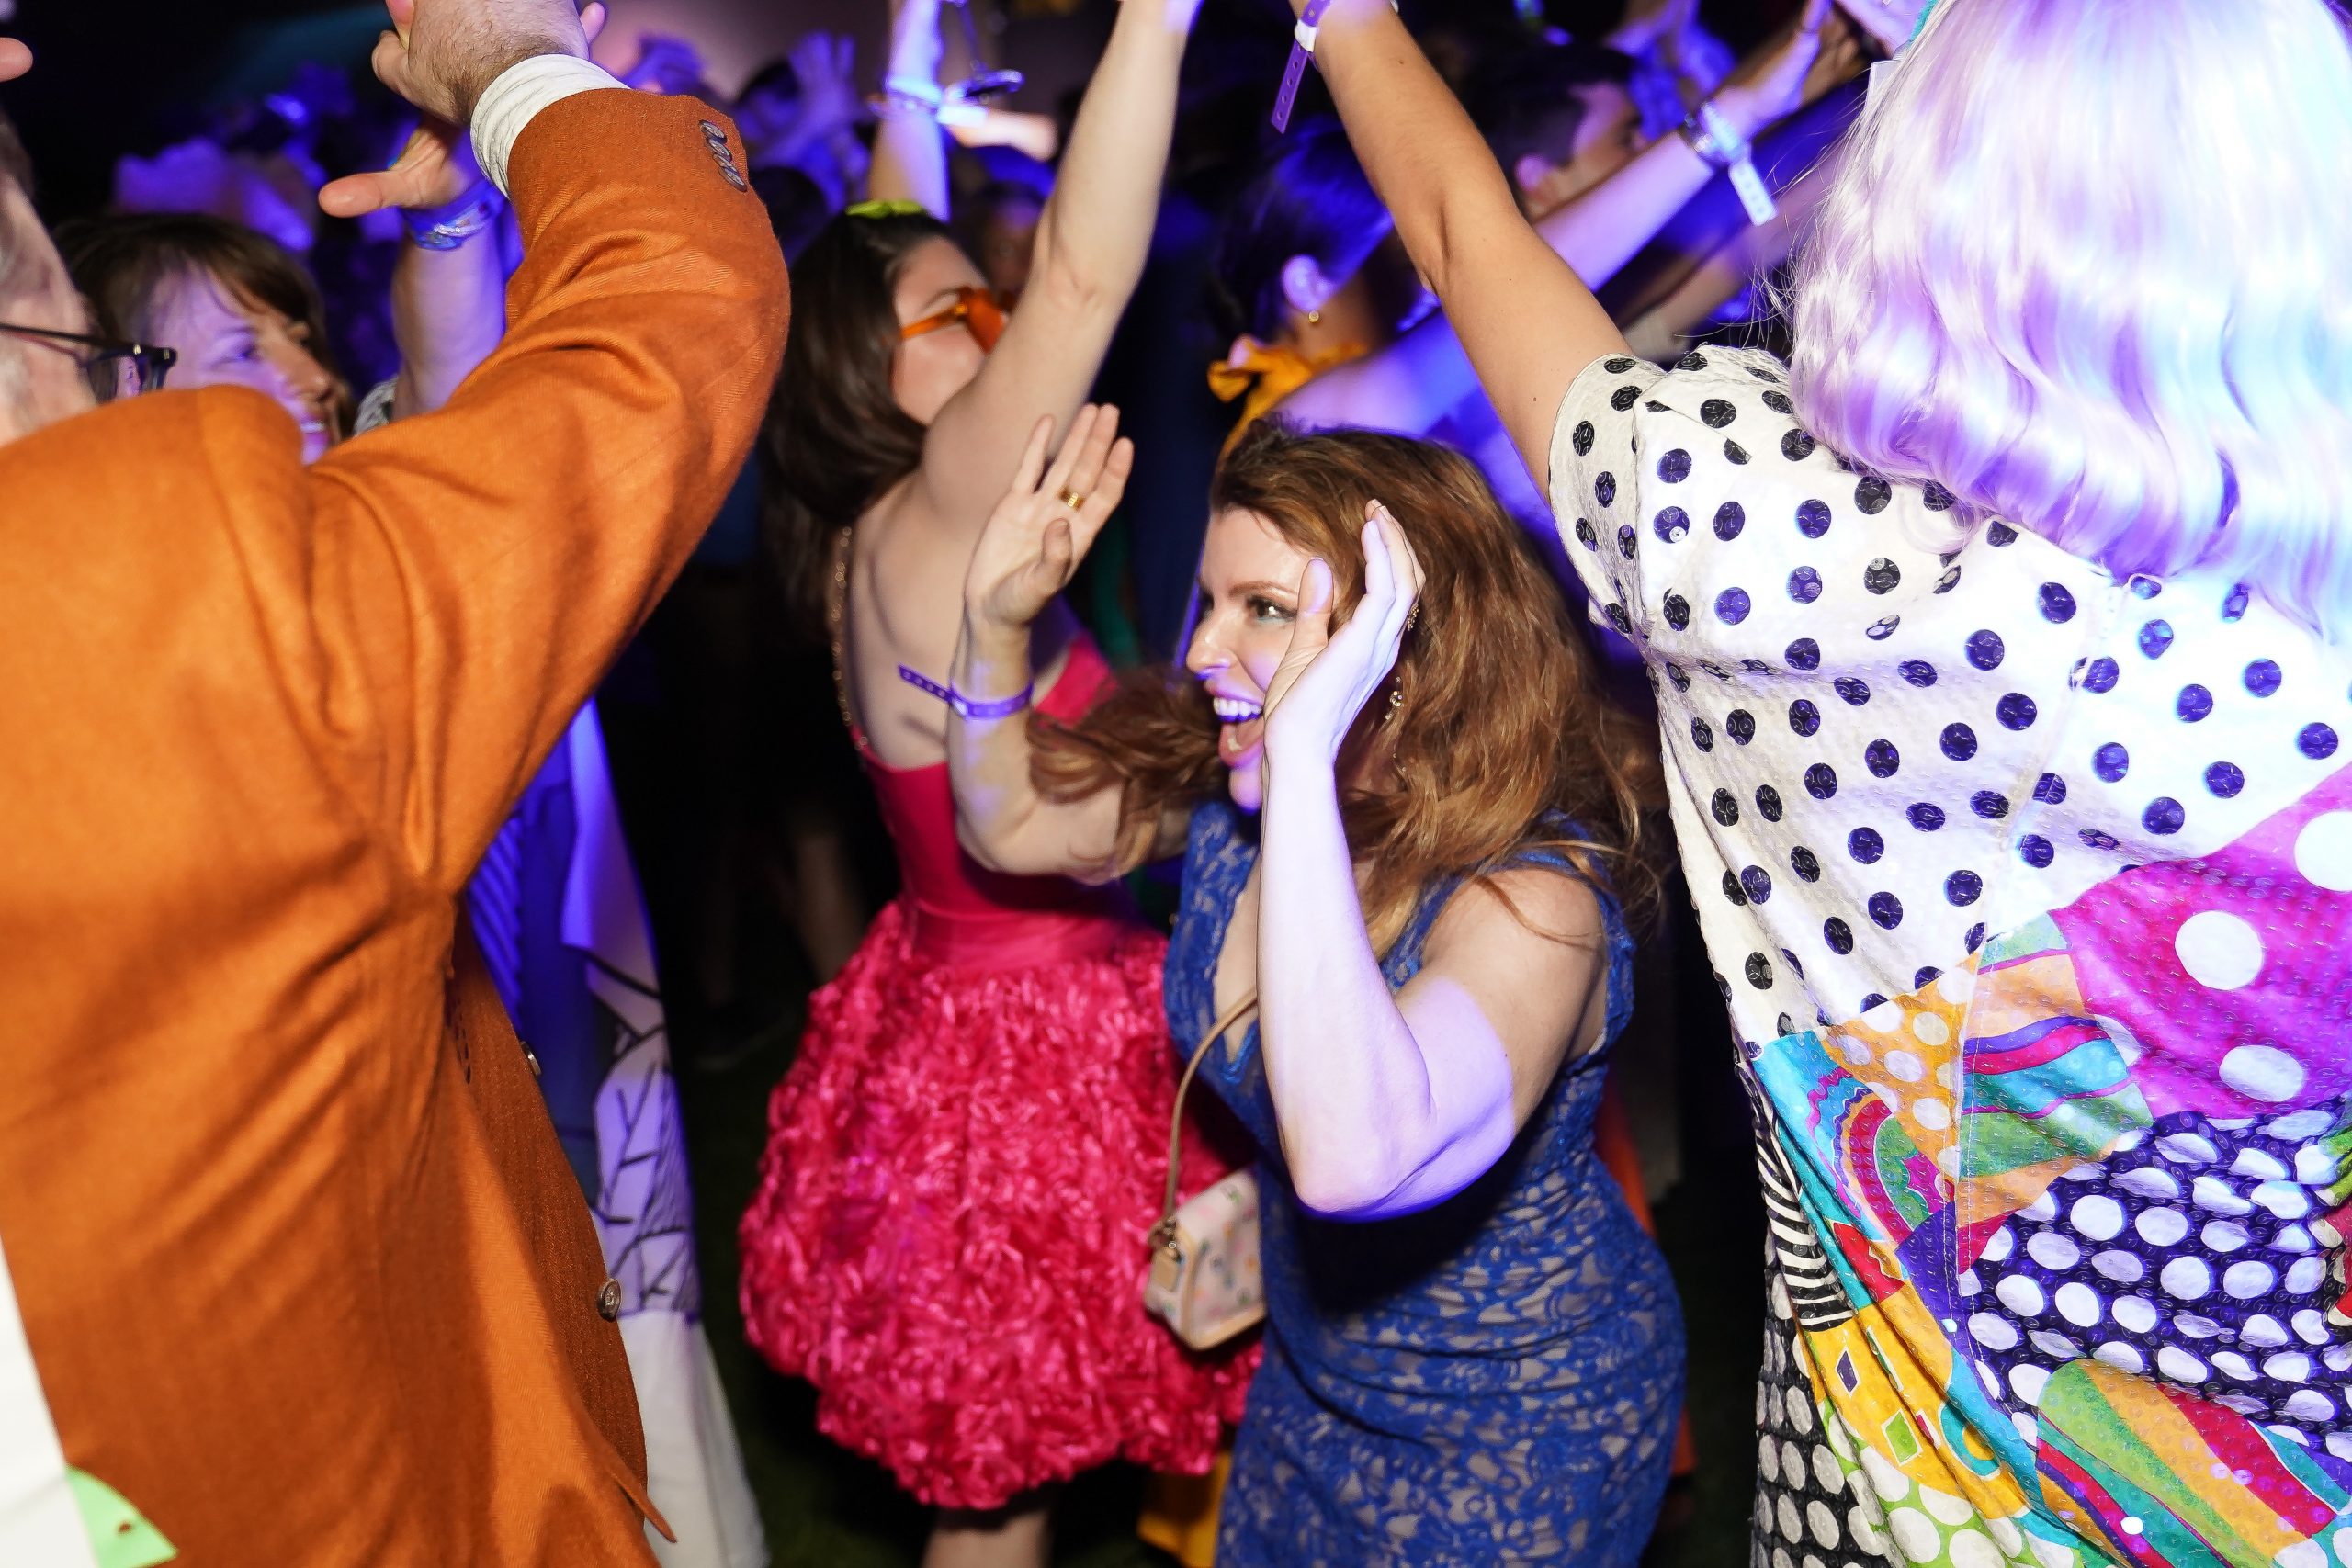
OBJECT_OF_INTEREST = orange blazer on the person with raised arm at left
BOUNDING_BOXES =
[0,92,786,1568]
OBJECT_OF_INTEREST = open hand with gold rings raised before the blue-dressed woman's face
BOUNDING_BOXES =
[965,404,1136,630]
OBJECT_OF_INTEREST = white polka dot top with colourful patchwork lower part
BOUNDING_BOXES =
[1550,350,2352,1568]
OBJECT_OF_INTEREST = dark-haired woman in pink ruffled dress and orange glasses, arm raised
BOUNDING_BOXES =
[741,0,1247,1565]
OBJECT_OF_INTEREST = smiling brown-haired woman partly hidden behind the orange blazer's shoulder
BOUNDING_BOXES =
[56,211,353,461]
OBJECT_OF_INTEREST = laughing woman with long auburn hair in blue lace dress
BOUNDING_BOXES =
[926,409,1681,1568]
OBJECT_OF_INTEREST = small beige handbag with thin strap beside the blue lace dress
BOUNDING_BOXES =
[1143,992,1265,1349]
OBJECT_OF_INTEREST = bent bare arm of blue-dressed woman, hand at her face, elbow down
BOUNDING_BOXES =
[1259,508,1601,1220]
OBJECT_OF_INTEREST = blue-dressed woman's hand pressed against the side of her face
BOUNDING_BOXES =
[1265,501,1423,769]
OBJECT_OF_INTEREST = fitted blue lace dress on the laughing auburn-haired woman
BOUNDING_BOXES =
[1167,802,1681,1568]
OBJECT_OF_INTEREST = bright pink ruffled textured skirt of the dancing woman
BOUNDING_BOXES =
[741,900,1256,1509]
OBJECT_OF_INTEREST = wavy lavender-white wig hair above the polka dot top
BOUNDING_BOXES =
[1792,0,2352,632]
